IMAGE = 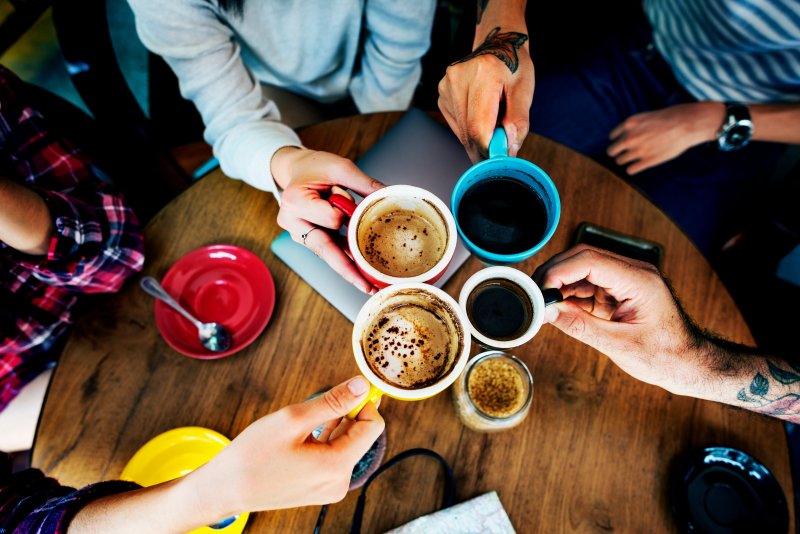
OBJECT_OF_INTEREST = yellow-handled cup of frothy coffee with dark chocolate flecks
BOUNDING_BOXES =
[347,283,471,419]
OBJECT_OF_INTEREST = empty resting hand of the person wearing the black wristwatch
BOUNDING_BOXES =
[606,102,725,175]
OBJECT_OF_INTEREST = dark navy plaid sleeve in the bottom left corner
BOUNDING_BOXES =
[0,453,141,534]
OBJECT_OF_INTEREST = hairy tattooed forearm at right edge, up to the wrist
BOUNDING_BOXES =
[690,336,800,423]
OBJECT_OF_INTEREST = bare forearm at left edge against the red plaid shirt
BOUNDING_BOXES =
[0,177,55,255]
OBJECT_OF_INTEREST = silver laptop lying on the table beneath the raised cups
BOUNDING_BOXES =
[270,109,471,322]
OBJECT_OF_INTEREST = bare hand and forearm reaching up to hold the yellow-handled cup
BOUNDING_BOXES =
[69,376,384,533]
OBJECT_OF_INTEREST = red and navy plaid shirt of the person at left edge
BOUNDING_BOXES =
[0,66,144,410]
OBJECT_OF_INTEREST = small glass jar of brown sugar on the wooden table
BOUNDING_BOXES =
[453,351,533,432]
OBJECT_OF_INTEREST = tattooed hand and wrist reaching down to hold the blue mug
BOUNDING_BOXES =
[439,0,534,161]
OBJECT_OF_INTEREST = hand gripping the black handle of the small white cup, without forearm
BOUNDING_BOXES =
[534,245,698,394]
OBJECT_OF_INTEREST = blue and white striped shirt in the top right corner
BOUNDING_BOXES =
[644,0,800,103]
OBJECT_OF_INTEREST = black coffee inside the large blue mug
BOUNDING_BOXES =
[457,176,547,254]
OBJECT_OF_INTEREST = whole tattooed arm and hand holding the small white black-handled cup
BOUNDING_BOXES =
[534,245,800,423]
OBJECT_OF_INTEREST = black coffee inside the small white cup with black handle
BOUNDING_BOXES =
[467,278,533,341]
